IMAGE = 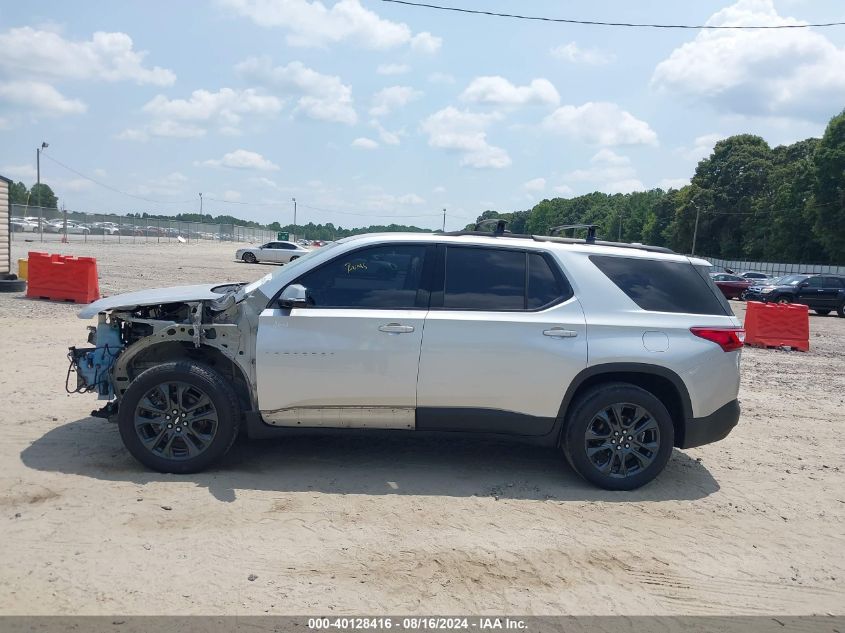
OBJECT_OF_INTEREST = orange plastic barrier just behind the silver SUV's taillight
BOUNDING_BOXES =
[745,301,810,352]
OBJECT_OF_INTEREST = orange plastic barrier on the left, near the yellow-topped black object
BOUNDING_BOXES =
[26,251,100,303]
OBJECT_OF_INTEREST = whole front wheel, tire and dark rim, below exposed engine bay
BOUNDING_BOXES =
[117,361,241,474]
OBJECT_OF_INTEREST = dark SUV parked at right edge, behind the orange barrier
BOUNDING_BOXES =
[744,275,845,317]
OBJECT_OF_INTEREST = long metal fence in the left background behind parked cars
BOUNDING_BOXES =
[10,204,276,244]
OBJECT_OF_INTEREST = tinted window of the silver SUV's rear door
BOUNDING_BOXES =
[433,246,572,311]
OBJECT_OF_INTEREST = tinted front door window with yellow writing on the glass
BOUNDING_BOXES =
[294,244,428,309]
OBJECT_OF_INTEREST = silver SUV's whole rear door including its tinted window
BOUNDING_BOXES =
[417,245,587,435]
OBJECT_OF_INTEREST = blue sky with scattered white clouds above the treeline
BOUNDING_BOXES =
[0,0,845,229]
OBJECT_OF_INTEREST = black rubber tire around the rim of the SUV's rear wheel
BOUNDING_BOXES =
[563,383,675,490]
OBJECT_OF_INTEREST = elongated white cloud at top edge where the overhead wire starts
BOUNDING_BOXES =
[218,0,440,52]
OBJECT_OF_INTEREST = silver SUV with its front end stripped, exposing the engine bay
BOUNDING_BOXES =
[69,227,743,490]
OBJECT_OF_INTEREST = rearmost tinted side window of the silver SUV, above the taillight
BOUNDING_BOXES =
[590,255,731,316]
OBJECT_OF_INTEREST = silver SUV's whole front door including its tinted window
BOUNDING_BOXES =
[256,243,434,428]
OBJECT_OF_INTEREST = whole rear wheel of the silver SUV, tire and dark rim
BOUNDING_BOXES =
[563,383,675,490]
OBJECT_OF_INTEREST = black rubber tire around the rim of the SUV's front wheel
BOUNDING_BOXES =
[117,361,240,474]
